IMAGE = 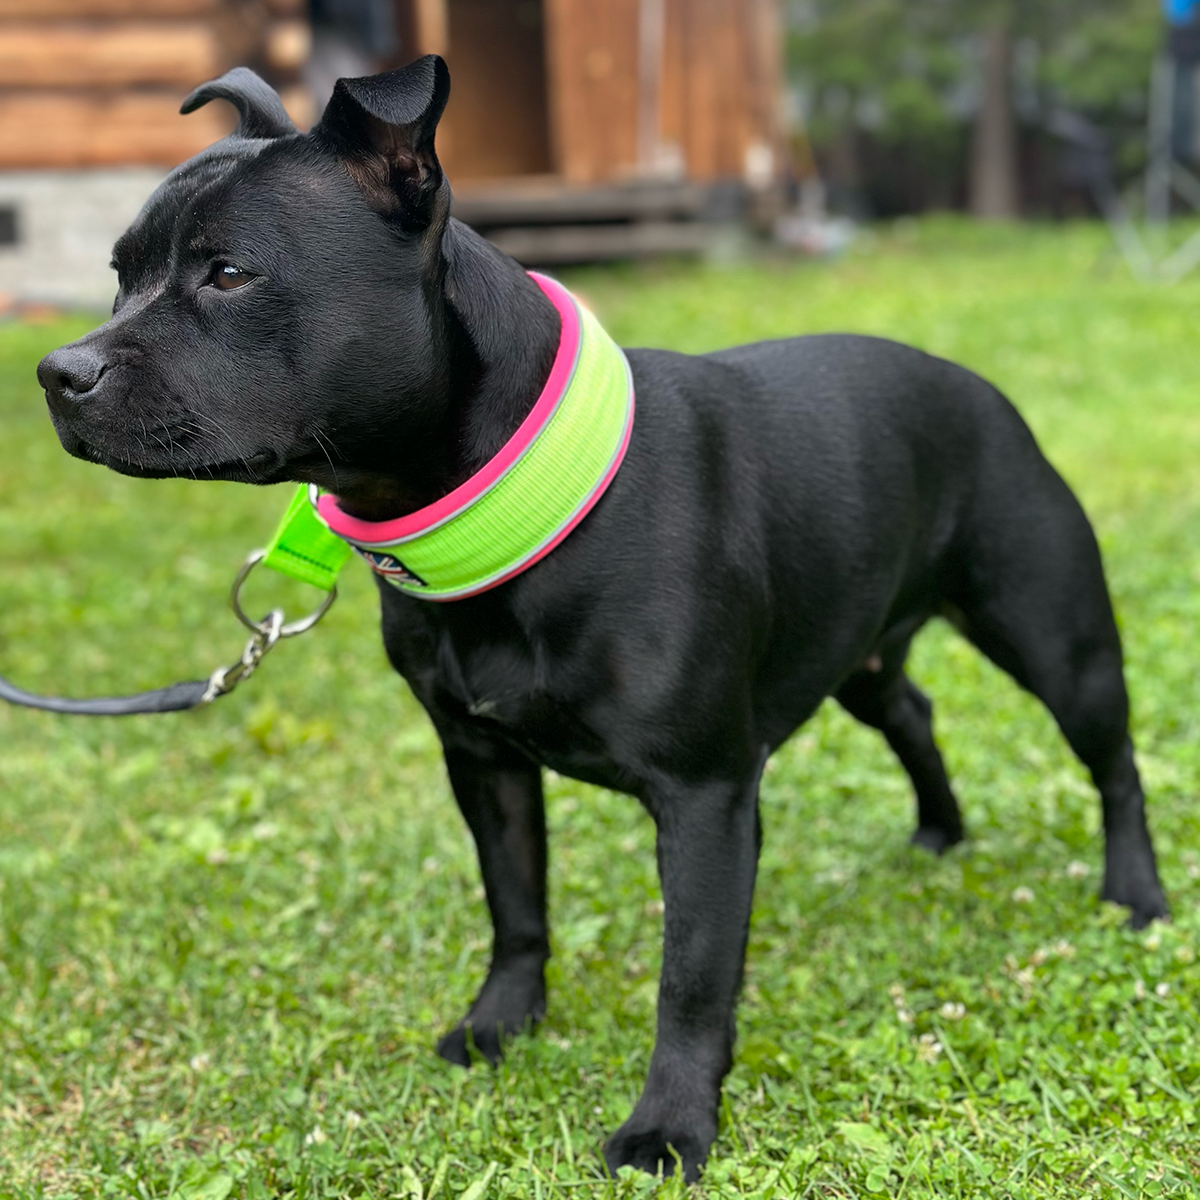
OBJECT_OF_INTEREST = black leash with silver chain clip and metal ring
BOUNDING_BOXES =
[0,550,337,716]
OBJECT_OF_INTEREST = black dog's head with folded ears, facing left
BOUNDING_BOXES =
[37,55,450,487]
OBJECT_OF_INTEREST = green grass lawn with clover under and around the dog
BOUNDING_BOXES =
[0,222,1200,1200]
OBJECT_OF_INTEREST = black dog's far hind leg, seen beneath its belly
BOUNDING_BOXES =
[834,641,964,854]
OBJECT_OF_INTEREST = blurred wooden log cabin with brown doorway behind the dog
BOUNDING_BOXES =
[0,0,784,280]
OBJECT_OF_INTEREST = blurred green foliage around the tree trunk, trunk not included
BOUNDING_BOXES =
[786,0,1164,216]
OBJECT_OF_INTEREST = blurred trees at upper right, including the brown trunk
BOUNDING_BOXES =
[787,0,1163,217]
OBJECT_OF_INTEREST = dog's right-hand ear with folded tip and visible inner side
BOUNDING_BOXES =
[313,54,450,229]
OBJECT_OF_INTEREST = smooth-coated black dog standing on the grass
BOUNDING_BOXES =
[38,56,1165,1178]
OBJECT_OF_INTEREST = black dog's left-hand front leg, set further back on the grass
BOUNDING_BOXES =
[438,736,550,1067]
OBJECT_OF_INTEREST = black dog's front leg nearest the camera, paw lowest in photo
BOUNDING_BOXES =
[605,752,766,1182]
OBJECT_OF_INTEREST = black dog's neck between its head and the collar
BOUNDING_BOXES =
[340,220,560,521]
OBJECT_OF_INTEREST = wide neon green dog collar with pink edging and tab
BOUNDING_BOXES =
[256,271,634,600]
